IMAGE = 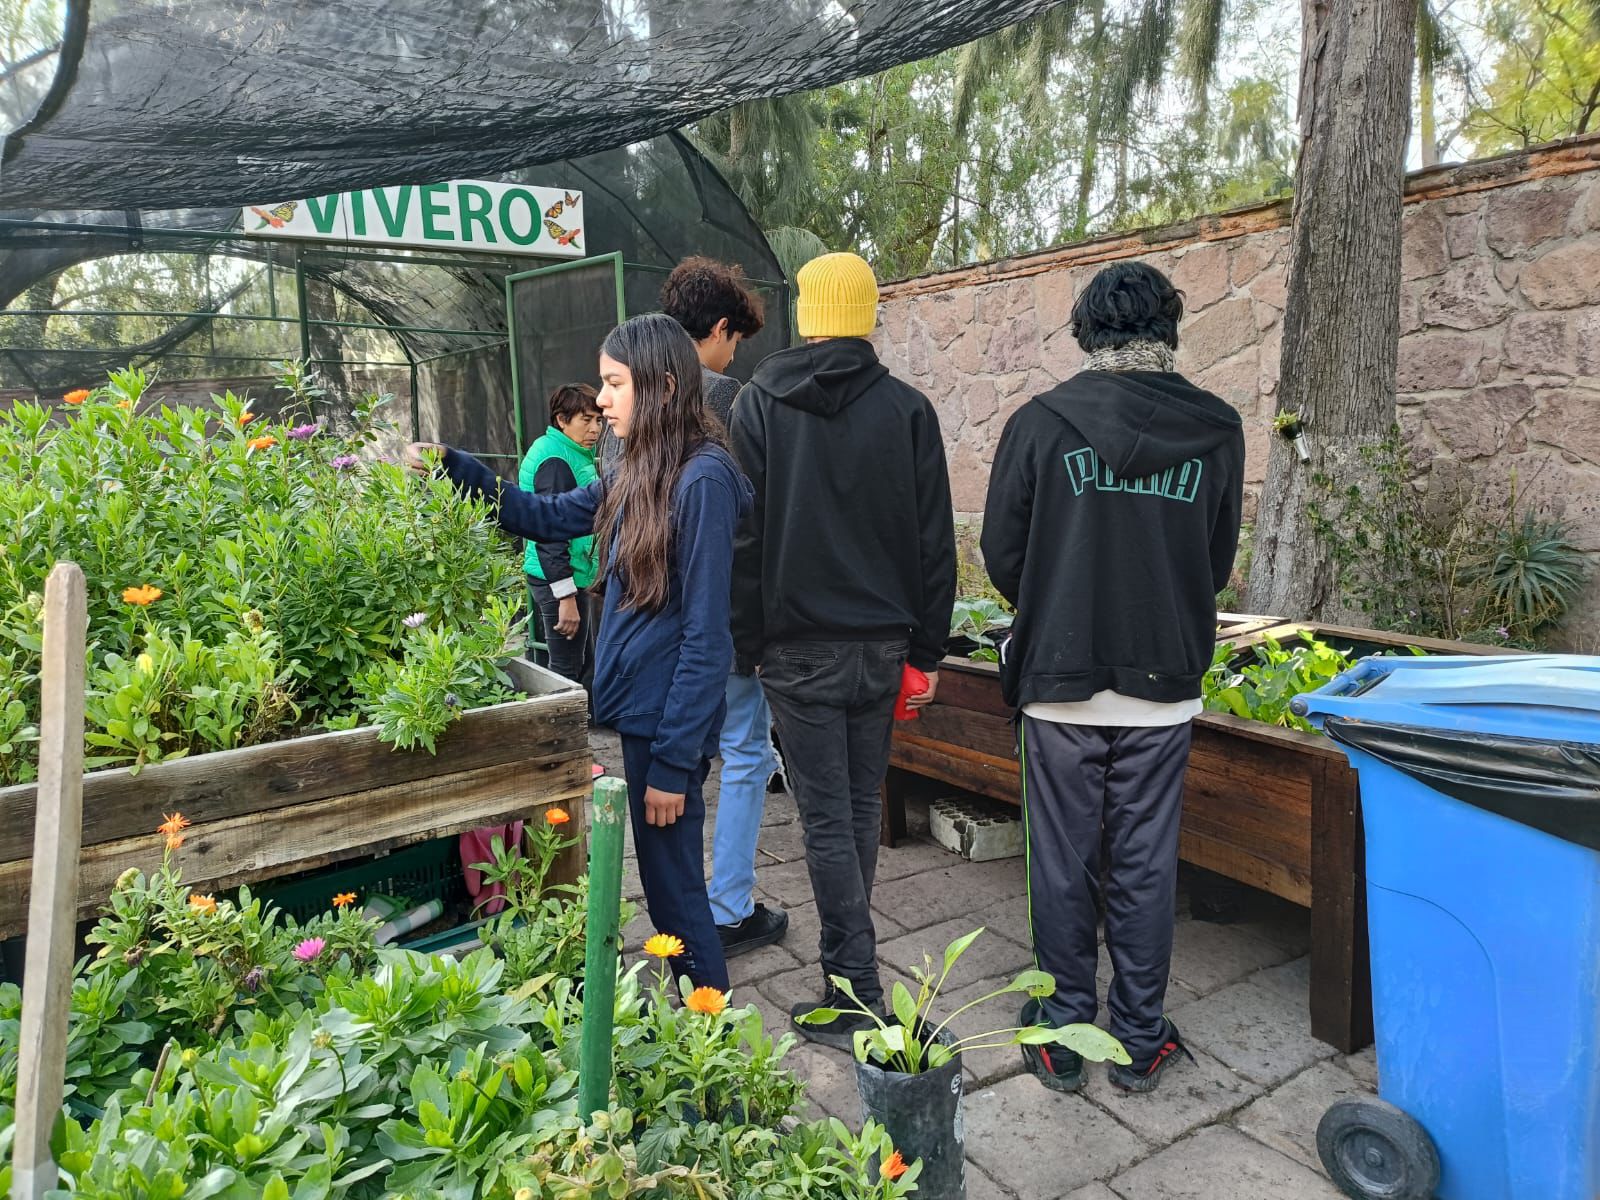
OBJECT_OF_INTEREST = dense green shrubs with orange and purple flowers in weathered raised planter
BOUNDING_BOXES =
[0,363,522,784]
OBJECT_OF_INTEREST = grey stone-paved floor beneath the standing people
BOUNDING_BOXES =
[594,733,1376,1200]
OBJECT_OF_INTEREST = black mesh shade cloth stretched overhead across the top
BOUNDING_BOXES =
[9,0,1053,208]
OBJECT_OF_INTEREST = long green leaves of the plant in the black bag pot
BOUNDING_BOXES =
[798,928,1131,1075]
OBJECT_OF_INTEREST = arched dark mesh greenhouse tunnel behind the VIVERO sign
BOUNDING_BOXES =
[0,134,790,456]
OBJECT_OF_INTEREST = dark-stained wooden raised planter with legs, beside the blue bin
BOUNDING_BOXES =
[883,616,1501,1053]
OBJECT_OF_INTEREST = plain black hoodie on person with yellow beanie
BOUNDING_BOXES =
[731,338,955,670]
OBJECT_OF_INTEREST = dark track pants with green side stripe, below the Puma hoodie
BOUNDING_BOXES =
[1021,717,1190,1062]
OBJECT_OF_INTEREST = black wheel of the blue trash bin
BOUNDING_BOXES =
[1317,1096,1438,1200]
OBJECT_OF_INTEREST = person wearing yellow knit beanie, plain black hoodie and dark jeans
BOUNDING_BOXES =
[731,254,955,1048]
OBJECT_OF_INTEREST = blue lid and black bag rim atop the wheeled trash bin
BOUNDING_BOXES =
[1291,654,1600,850]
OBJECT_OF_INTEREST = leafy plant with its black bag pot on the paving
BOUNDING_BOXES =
[800,928,1131,1200]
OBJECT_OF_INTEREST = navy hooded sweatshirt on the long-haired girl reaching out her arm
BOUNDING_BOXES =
[443,445,752,795]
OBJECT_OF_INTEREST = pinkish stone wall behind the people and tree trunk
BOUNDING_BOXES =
[875,138,1600,643]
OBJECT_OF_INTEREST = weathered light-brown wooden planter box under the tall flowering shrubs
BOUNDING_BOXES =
[0,659,594,938]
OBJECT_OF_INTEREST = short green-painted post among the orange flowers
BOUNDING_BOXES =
[578,776,627,1118]
